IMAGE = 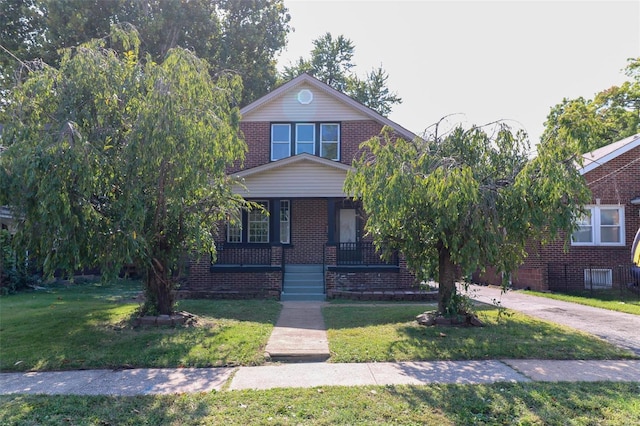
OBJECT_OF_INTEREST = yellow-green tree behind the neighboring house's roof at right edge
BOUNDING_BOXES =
[542,58,640,153]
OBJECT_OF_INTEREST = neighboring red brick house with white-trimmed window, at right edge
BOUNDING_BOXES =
[476,134,640,291]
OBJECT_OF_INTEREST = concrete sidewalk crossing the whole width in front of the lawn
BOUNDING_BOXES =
[6,360,640,396]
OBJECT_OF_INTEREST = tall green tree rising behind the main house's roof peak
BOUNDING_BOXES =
[281,33,402,116]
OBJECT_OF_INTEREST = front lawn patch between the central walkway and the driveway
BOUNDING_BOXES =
[323,305,635,362]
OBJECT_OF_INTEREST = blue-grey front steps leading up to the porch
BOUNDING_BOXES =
[280,265,326,301]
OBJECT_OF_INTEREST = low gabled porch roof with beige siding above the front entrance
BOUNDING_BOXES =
[233,154,352,199]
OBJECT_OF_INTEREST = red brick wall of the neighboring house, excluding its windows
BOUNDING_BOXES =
[514,147,640,290]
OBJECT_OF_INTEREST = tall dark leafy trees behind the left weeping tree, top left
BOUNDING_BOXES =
[0,0,290,104]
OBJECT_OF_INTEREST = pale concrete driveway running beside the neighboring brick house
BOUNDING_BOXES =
[469,285,640,355]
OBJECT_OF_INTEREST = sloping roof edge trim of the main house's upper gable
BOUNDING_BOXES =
[240,74,417,140]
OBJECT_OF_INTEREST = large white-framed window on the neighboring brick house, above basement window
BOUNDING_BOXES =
[571,205,624,246]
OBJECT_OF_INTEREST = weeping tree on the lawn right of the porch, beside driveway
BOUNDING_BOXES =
[345,121,589,316]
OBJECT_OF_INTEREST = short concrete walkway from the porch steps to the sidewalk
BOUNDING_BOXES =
[265,302,330,362]
